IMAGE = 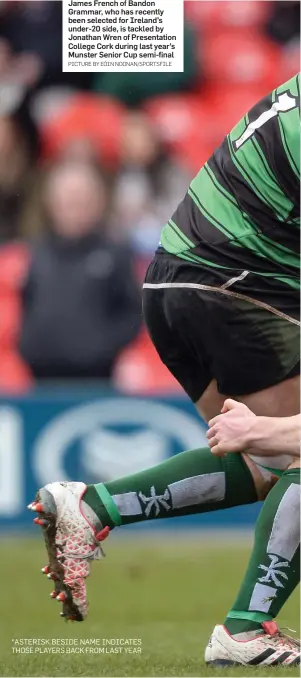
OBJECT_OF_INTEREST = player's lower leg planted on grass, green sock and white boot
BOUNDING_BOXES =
[205,465,300,666]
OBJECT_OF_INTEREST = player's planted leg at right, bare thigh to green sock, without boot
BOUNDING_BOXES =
[206,376,300,636]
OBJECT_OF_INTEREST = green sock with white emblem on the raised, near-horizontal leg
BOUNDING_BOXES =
[83,447,258,529]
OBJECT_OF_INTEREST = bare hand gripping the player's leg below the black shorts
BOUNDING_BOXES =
[206,398,256,457]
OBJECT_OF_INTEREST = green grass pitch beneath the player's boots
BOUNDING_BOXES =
[0,531,299,677]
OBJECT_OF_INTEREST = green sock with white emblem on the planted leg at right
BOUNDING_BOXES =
[225,469,300,635]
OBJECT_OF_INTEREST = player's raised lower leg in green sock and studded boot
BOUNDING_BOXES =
[29,440,258,621]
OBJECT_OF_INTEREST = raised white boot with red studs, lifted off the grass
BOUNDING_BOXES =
[28,482,110,621]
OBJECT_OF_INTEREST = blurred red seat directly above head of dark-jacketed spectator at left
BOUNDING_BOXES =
[41,94,125,165]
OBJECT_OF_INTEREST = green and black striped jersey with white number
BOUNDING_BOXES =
[160,74,300,289]
